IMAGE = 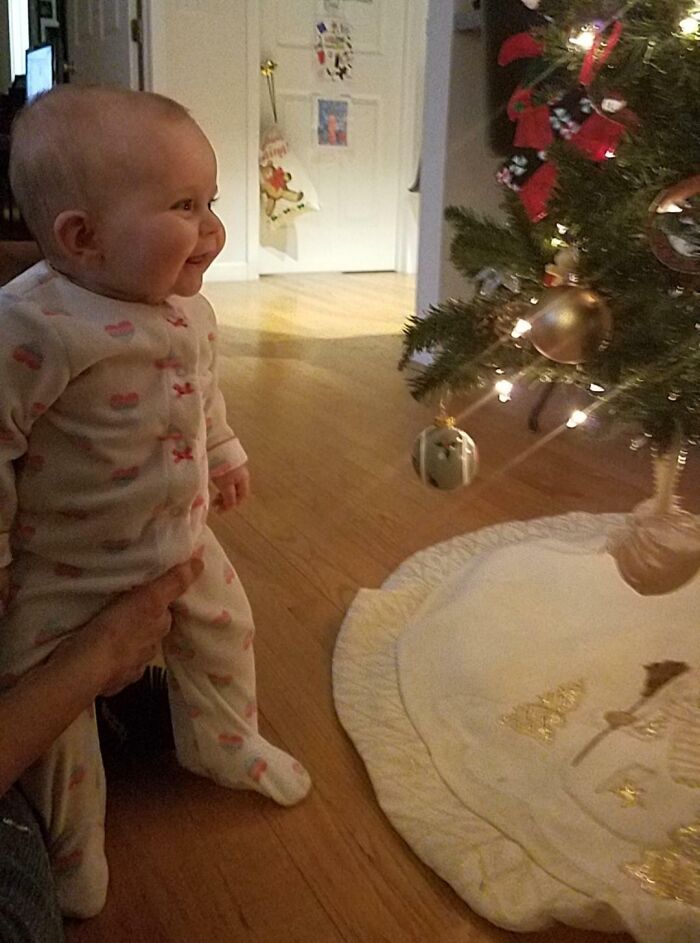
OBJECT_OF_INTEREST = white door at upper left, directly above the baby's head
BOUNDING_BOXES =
[66,0,141,88]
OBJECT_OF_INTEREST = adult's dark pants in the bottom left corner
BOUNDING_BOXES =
[0,788,64,943]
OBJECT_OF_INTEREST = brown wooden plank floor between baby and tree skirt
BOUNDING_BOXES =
[64,274,698,943]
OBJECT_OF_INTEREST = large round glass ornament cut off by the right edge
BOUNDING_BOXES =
[647,176,700,286]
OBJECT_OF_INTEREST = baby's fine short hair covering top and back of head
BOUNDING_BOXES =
[10,85,193,259]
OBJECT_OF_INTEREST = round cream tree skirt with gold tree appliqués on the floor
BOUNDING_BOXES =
[333,514,700,943]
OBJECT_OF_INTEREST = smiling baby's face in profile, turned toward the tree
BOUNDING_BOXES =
[90,120,225,304]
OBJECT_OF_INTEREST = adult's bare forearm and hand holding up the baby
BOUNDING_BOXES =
[0,560,203,795]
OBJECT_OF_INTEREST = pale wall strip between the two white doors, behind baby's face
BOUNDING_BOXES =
[147,0,258,281]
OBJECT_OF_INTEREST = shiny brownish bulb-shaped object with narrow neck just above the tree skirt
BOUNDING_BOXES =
[608,437,700,596]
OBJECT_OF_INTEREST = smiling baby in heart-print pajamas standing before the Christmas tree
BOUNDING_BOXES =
[0,86,310,917]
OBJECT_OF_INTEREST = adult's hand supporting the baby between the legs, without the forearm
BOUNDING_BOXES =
[64,558,204,695]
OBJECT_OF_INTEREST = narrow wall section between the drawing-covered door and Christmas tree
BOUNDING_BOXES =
[417,0,502,311]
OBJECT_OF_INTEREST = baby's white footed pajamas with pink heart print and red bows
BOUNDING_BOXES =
[0,262,310,916]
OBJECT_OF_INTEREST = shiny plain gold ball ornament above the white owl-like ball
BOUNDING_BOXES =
[527,286,613,363]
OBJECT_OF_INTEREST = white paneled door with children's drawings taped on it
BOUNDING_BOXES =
[259,0,422,274]
